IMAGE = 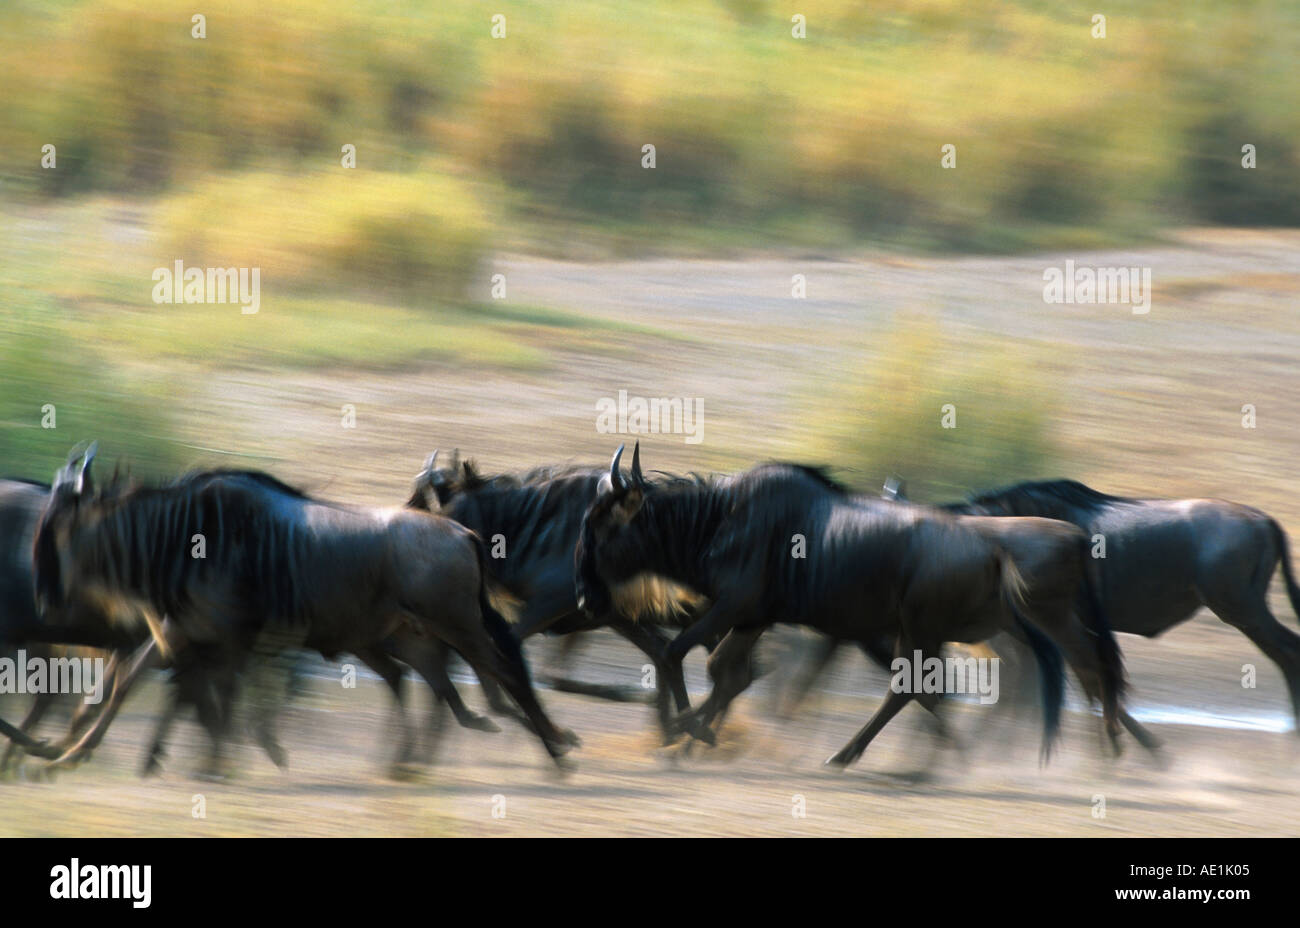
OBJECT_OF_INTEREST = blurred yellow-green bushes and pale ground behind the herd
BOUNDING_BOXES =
[0,0,1300,833]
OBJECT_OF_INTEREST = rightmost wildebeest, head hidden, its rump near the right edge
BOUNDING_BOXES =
[899,480,1300,730]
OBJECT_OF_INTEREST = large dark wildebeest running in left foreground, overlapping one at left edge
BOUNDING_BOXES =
[35,447,569,764]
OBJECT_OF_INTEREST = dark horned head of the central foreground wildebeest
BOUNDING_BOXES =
[575,442,646,616]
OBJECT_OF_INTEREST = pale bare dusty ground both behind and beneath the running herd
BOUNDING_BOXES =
[0,231,1300,836]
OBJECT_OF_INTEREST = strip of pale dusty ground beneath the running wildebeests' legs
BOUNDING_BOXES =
[0,629,1300,836]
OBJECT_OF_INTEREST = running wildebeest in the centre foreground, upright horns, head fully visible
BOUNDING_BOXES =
[576,447,1123,766]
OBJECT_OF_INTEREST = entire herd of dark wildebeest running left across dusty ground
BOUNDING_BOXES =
[0,445,1300,775]
